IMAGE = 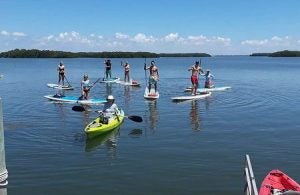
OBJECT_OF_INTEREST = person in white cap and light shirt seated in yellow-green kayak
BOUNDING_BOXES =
[98,95,120,124]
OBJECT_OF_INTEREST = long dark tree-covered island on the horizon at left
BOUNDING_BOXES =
[0,49,211,58]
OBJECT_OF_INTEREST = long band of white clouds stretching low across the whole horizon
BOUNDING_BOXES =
[0,30,300,55]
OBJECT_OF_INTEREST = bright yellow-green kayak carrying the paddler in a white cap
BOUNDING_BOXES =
[84,110,124,138]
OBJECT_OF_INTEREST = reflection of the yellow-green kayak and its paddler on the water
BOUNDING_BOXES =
[85,127,120,158]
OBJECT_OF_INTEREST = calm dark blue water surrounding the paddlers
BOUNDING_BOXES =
[0,56,300,195]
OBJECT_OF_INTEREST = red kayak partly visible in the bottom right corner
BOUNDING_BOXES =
[259,170,300,195]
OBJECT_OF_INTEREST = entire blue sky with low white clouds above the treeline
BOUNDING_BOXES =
[0,0,300,55]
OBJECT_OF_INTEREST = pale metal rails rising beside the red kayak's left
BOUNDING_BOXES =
[244,154,258,195]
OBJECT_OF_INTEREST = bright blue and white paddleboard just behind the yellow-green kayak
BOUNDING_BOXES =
[44,94,106,105]
